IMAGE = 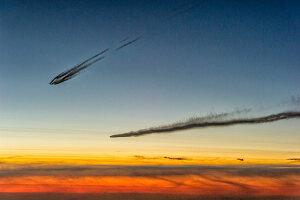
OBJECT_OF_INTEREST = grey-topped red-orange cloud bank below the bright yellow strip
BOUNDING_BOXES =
[0,165,300,199]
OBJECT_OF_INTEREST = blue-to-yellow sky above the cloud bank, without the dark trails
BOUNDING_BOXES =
[0,0,300,198]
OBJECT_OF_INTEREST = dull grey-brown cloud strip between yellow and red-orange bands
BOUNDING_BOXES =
[0,164,300,178]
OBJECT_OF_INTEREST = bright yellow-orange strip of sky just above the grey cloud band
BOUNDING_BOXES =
[0,156,300,165]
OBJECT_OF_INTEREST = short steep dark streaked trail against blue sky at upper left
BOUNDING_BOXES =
[49,49,109,85]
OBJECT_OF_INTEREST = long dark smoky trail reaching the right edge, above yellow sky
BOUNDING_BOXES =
[110,112,300,138]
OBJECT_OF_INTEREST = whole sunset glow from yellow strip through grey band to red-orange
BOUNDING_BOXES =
[0,155,300,196]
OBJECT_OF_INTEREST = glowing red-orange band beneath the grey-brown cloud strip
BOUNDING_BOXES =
[0,175,300,195]
